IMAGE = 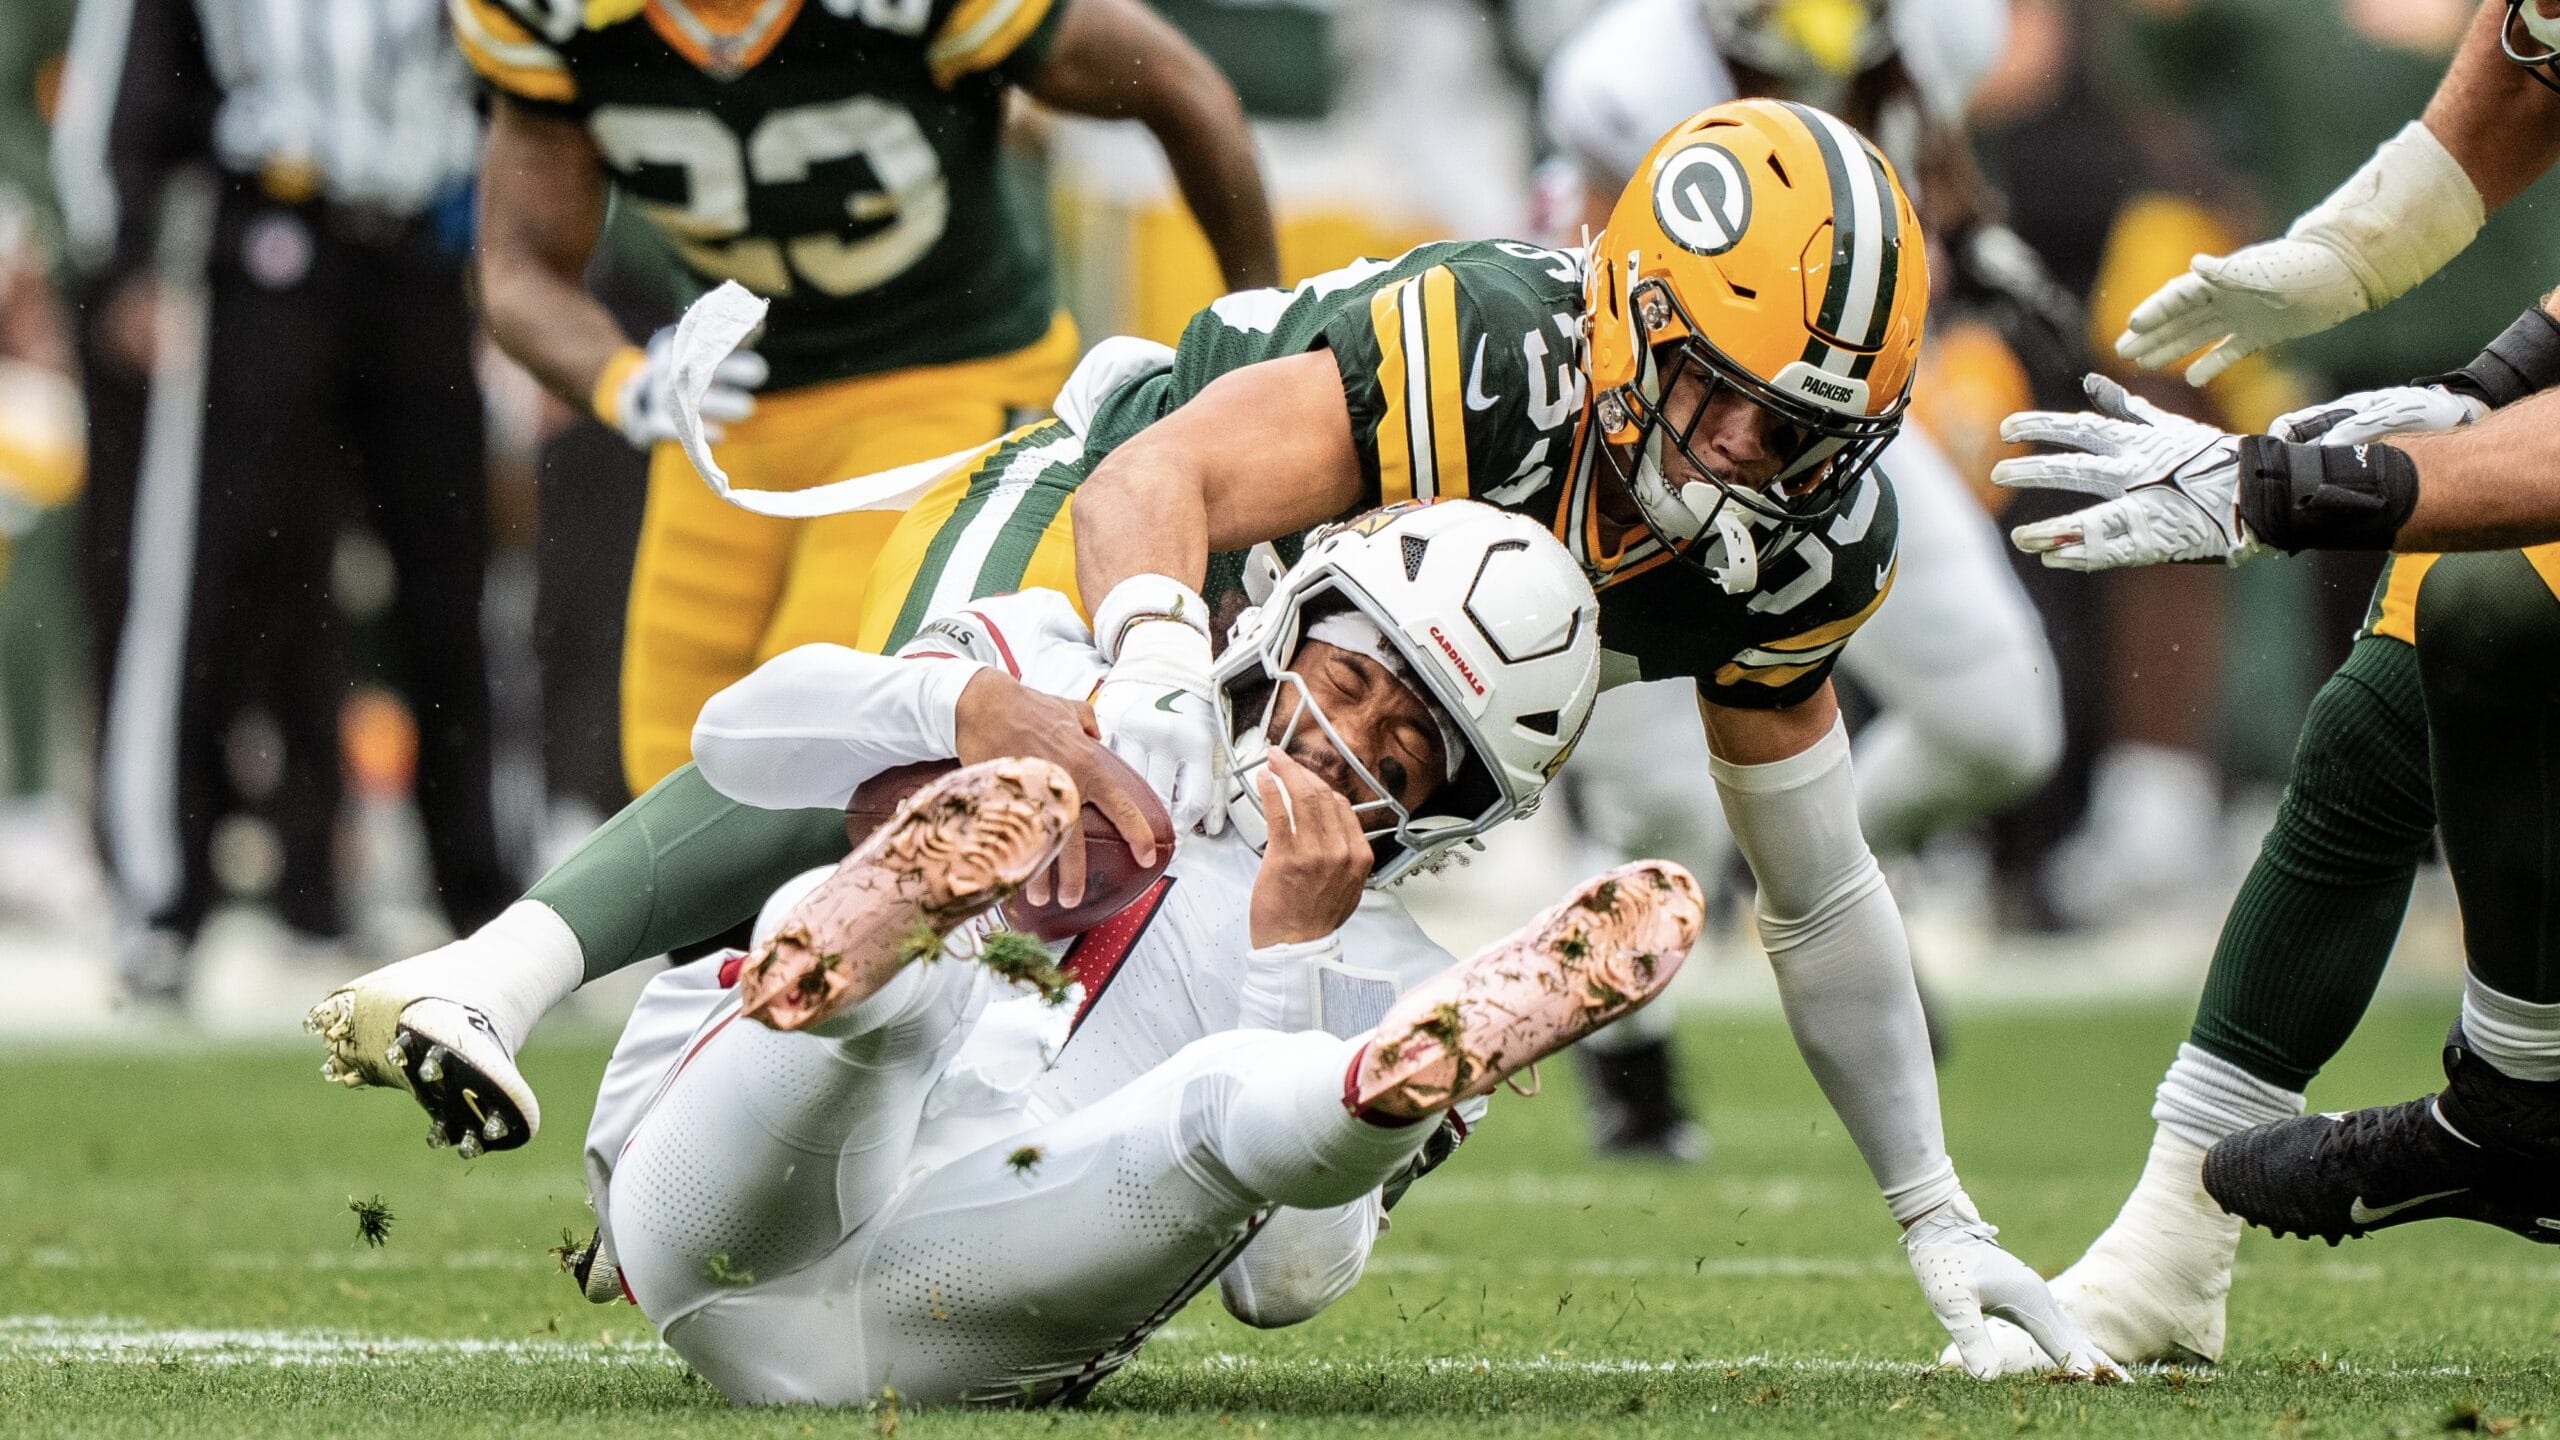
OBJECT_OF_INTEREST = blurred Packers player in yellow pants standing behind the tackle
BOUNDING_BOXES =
[451,0,1275,814]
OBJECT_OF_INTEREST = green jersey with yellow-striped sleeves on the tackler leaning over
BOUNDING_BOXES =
[1085,241,1894,710]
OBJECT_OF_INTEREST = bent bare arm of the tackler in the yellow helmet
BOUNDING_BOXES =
[1075,351,1362,599]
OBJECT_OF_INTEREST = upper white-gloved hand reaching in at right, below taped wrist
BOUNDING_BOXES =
[2115,238,2373,384]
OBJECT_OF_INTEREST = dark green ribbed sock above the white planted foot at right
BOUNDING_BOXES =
[2189,635,2435,1092]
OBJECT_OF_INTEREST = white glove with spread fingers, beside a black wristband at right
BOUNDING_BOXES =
[1992,374,2266,569]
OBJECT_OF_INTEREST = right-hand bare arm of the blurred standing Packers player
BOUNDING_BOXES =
[1024,0,1280,290]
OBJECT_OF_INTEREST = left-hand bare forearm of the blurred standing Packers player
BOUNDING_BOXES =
[479,95,630,413]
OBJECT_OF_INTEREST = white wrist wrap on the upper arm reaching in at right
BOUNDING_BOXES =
[2286,120,2486,307]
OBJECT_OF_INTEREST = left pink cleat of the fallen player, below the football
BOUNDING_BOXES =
[737,758,1080,1030]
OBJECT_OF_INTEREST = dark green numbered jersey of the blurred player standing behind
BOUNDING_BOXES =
[451,0,1070,389]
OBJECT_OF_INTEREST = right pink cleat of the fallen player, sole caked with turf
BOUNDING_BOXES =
[1352,861,1705,1120]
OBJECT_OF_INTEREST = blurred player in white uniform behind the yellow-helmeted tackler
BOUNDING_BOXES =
[1539,0,2063,1158]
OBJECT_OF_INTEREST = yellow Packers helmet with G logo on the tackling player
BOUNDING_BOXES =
[1585,100,1928,579]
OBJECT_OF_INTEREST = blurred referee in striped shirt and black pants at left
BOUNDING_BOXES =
[54,0,509,999]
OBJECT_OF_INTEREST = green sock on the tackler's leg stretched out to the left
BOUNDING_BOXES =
[525,766,852,981]
